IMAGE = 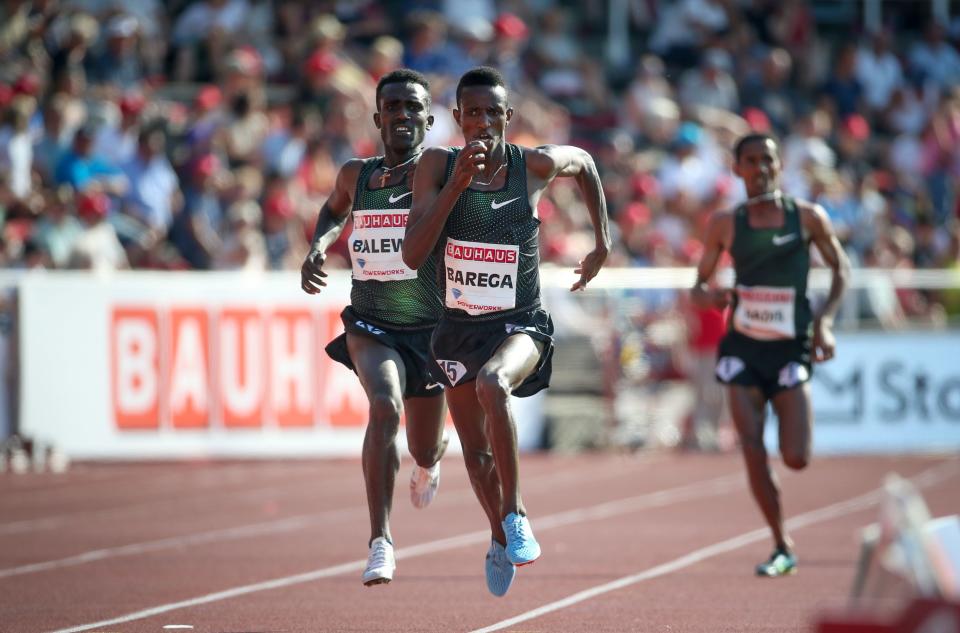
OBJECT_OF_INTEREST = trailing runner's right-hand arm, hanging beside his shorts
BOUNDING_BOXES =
[797,201,850,362]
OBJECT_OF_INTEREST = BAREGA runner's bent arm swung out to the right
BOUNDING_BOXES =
[524,145,610,291]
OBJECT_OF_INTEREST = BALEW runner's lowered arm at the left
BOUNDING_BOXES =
[300,158,363,295]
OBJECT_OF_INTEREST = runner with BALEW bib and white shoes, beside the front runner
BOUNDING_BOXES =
[301,70,447,586]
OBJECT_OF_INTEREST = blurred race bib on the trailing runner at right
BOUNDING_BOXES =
[733,286,797,341]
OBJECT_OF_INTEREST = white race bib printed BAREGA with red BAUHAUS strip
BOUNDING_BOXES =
[443,238,520,314]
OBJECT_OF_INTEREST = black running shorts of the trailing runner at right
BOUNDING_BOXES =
[715,331,813,399]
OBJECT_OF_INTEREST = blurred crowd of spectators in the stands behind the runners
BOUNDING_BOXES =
[0,0,960,316]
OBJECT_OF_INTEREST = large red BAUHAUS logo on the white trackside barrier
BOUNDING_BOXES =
[110,306,367,431]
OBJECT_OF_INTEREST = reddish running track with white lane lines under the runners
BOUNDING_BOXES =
[0,454,960,633]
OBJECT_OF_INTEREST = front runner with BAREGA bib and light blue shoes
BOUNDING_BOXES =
[403,67,610,596]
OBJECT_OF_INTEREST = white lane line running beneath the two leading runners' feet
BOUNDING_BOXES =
[53,473,745,633]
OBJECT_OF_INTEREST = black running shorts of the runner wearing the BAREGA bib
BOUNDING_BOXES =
[429,308,553,398]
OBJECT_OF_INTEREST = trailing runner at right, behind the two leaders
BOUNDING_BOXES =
[692,134,850,577]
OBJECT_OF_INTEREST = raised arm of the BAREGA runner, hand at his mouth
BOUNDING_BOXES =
[402,142,486,270]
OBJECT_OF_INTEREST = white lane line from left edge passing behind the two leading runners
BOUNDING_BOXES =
[0,456,689,579]
